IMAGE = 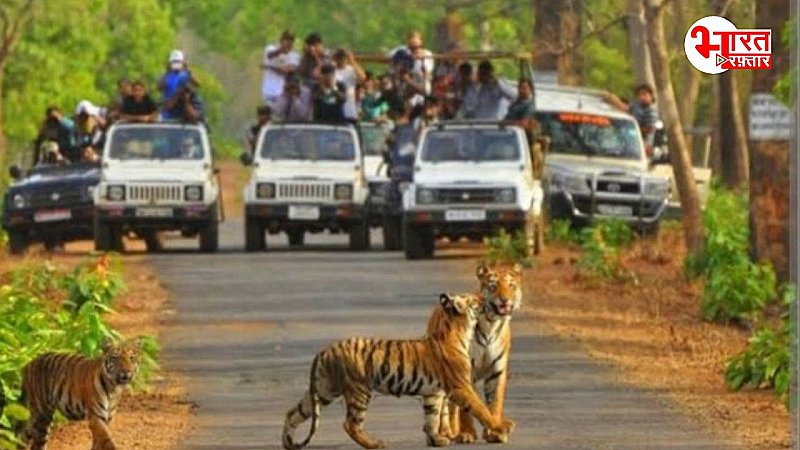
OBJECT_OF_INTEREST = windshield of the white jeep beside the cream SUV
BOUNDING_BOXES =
[421,129,521,162]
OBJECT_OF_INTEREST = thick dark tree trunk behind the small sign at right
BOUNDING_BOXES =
[750,0,791,281]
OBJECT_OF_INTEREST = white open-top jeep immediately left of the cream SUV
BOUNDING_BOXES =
[403,122,544,259]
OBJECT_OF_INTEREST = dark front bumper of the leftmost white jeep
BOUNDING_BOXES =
[95,205,217,229]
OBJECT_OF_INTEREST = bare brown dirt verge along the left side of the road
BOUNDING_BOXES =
[0,246,193,450]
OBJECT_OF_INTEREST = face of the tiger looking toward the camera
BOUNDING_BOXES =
[477,264,522,317]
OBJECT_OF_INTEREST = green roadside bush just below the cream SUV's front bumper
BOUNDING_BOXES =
[578,220,634,280]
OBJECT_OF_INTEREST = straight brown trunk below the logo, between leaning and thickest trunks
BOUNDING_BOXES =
[717,70,750,189]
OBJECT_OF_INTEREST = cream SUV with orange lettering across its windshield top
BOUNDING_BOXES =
[536,86,670,231]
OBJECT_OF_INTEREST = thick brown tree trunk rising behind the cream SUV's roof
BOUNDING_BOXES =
[532,0,583,85]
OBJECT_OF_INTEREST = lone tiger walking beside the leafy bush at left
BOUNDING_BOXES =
[21,338,142,450]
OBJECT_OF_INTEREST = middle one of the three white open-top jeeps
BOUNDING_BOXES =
[242,123,369,251]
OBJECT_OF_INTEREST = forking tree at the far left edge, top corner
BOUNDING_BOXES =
[0,0,36,162]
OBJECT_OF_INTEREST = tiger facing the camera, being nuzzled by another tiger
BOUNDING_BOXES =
[440,264,522,443]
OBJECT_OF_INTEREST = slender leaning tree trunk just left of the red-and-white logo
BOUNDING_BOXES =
[643,0,705,255]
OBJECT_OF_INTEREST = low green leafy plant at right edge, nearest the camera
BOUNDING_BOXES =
[725,289,795,408]
